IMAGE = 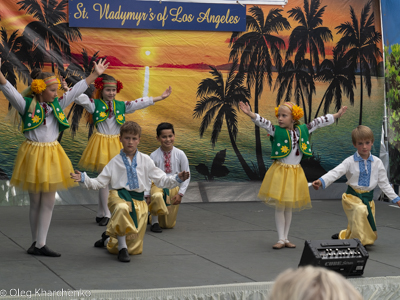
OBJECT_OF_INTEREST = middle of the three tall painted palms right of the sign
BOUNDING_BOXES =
[286,0,333,123]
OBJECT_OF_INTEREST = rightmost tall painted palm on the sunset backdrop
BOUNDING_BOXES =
[336,0,382,125]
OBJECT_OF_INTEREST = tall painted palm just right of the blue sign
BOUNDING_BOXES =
[229,6,290,176]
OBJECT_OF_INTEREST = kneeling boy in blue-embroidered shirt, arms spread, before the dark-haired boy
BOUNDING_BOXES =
[71,121,189,262]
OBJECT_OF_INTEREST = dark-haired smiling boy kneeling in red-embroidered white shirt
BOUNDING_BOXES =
[145,123,189,233]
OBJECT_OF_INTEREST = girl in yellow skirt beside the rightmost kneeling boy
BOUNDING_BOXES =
[239,102,347,249]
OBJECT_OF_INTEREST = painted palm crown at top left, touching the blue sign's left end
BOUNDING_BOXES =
[17,0,82,73]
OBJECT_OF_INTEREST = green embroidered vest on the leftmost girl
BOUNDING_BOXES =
[21,97,69,132]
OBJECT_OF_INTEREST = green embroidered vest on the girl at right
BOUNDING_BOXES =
[270,124,312,159]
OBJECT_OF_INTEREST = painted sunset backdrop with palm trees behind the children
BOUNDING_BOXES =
[0,0,384,185]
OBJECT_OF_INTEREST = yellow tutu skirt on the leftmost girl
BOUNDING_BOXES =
[11,140,78,193]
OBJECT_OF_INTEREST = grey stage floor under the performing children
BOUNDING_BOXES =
[0,190,400,291]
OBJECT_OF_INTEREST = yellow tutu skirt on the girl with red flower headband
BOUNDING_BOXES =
[78,132,122,172]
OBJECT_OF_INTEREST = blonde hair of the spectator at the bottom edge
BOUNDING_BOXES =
[269,266,363,300]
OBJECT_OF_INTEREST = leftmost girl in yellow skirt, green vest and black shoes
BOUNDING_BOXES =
[0,59,108,257]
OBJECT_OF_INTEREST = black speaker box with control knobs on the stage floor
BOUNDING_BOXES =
[299,239,369,276]
